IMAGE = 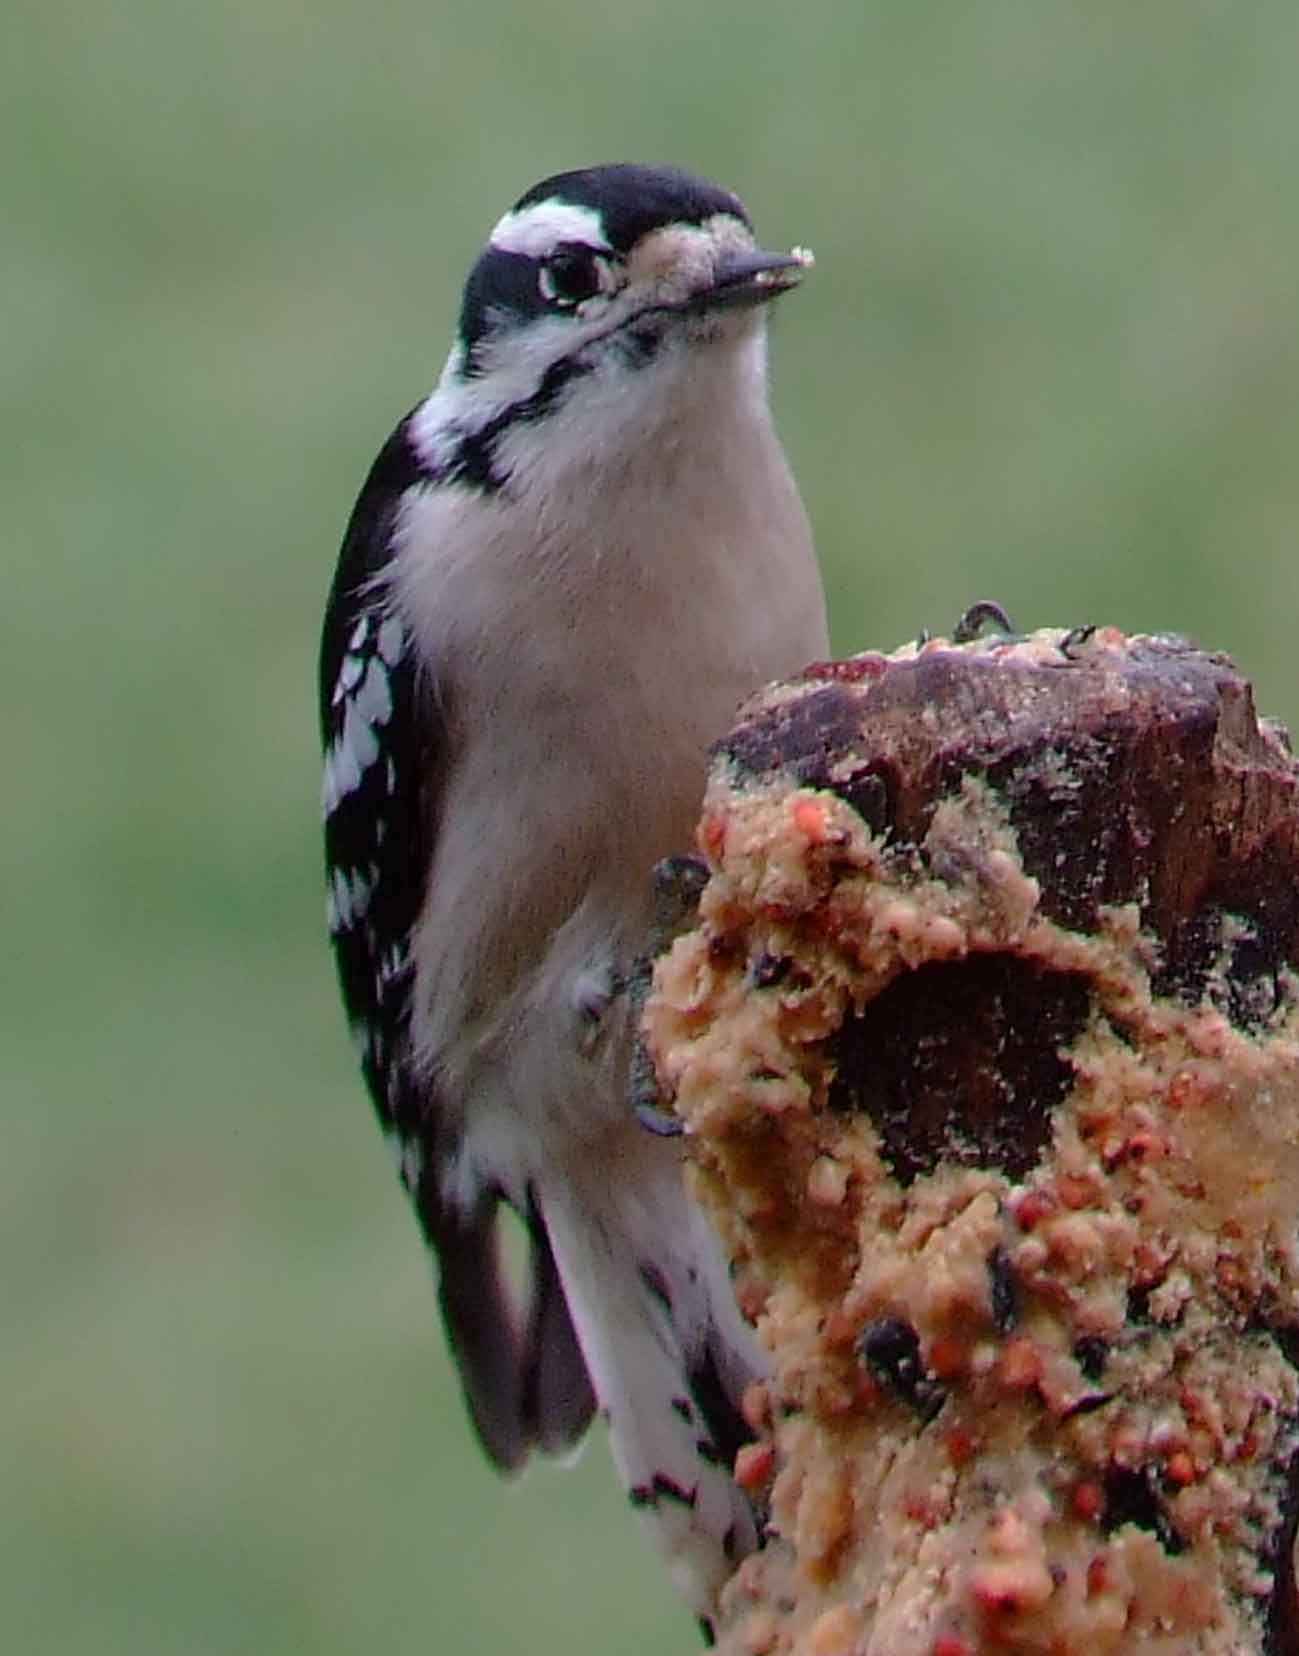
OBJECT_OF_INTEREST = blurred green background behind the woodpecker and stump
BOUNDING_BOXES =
[10,0,1299,1656]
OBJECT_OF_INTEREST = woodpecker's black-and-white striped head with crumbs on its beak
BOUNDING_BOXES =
[413,164,812,492]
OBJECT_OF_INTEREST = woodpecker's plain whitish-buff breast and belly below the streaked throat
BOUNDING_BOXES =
[394,319,827,1192]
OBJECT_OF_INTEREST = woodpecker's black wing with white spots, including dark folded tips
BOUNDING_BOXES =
[320,421,595,1471]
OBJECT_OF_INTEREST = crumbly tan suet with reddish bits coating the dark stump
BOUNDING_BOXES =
[645,631,1299,1656]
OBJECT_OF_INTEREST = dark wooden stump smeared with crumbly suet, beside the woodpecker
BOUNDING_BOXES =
[645,629,1299,1656]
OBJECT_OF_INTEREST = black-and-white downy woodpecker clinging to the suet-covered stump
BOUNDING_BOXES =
[320,166,827,1616]
